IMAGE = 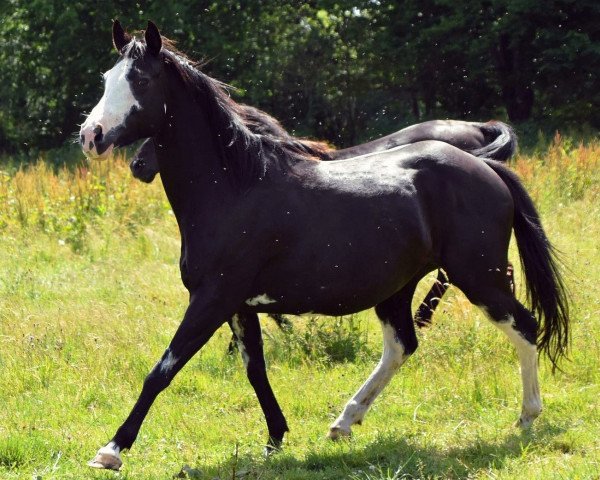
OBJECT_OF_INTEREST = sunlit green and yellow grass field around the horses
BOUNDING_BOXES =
[0,138,600,480]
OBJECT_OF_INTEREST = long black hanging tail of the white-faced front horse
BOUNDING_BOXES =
[484,160,569,372]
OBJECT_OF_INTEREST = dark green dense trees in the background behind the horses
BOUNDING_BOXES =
[0,0,600,152]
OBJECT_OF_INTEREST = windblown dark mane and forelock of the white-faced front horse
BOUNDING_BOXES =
[124,37,332,186]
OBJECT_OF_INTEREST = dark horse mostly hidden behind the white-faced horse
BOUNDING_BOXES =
[129,109,517,332]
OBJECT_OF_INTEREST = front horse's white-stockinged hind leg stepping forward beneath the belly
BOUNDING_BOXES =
[328,277,420,440]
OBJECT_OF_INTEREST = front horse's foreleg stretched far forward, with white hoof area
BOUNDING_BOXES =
[89,292,235,470]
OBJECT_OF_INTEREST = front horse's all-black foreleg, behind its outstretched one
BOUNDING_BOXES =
[229,313,288,453]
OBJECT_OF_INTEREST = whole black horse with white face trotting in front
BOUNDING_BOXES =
[81,22,569,468]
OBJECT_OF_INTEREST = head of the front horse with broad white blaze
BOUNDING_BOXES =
[79,20,166,159]
